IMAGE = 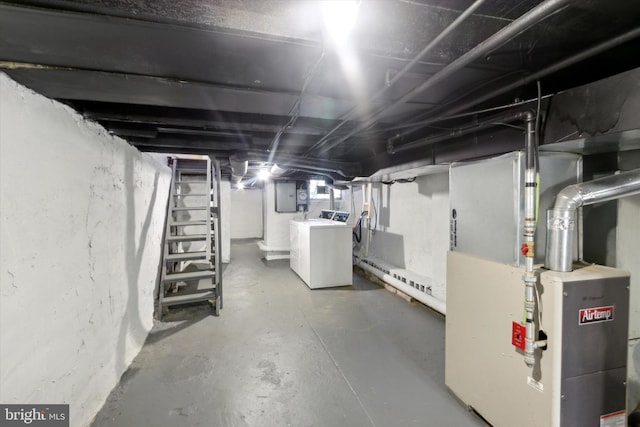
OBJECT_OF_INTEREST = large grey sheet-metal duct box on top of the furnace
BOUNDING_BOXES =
[449,151,582,265]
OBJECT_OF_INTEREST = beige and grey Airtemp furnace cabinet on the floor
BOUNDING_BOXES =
[445,252,629,427]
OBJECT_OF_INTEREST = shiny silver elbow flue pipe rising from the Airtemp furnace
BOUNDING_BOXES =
[545,169,640,271]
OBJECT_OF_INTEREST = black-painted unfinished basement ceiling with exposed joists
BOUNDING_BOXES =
[0,0,640,179]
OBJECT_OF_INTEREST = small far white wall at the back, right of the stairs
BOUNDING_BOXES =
[231,188,262,239]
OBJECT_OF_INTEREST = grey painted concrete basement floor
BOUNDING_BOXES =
[93,240,485,427]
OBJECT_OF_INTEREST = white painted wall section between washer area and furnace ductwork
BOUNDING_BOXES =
[354,173,449,301]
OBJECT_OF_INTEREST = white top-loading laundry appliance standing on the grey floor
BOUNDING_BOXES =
[289,218,353,289]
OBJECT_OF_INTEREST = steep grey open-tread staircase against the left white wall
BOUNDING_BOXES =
[158,157,222,317]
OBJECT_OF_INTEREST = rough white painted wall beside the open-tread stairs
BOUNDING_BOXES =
[0,74,170,426]
